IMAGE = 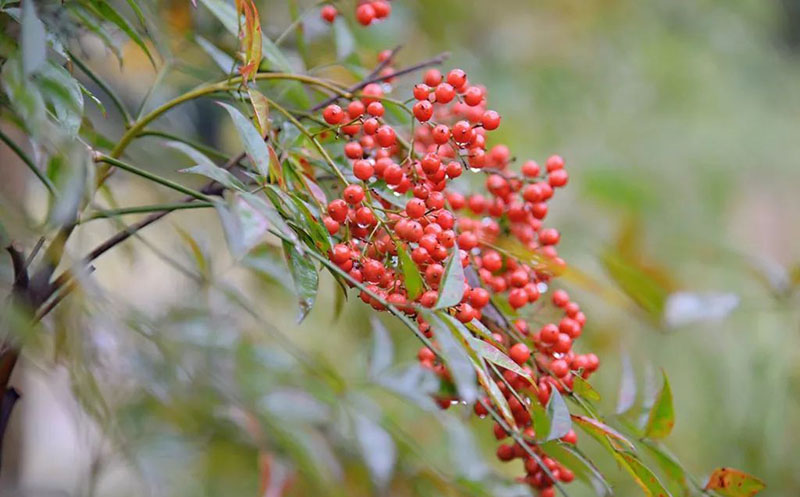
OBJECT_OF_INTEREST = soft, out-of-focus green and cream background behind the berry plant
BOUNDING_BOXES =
[0,0,800,496]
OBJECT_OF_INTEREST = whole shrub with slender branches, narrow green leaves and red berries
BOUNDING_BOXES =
[0,0,763,496]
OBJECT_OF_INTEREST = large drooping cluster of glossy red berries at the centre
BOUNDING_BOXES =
[322,64,598,496]
